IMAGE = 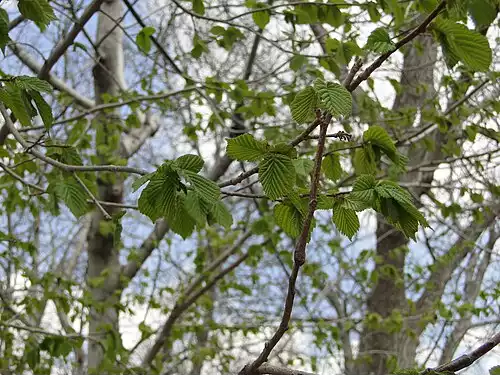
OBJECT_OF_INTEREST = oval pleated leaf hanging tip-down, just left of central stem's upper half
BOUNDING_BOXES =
[259,153,295,200]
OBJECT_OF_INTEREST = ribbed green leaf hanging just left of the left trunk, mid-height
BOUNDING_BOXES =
[48,176,90,218]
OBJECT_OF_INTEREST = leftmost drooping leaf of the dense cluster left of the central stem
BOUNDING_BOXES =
[138,168,180,222]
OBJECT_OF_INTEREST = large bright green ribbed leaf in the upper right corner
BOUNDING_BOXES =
[435,19,492,72]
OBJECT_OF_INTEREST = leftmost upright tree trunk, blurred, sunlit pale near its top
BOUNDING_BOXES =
[87,0,124,374]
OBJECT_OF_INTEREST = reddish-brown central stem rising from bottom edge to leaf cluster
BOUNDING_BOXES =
[239,114,332,375]
